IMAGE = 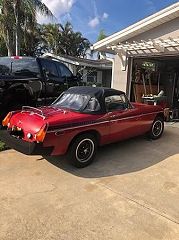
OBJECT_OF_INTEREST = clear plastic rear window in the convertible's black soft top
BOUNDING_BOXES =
[53,93,89,111]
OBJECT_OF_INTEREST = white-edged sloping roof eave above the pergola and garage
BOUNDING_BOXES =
[91,2,179,52]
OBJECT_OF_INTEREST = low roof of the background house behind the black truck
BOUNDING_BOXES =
[43,53,112,69]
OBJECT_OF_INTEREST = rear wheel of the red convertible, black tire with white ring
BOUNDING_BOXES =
[67,134,98,168]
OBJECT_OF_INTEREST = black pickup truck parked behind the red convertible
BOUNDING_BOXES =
[0,57,80,120]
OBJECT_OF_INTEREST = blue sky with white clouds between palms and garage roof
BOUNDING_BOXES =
[38,0,178,43]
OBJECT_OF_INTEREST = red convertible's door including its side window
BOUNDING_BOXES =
[105,94,141,142]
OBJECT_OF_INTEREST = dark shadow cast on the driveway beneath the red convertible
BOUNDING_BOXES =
[45,128,179,178]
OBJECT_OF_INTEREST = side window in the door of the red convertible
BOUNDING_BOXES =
[105,94,129,112]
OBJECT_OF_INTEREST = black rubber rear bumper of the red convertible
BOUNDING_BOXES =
[0,129,53,155]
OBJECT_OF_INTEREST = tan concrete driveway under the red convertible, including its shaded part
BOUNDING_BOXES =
[0,125,179,240]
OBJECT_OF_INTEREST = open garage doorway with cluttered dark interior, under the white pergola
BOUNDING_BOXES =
[130,56,179,119]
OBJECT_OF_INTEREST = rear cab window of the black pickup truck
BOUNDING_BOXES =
[0,57,40,78]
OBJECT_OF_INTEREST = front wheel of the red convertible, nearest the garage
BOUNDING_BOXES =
[148,117,164,140]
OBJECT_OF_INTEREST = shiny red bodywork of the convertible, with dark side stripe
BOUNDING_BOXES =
[0,87,163,155]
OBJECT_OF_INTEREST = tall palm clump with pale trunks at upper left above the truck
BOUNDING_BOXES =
[0,0,53,55]
